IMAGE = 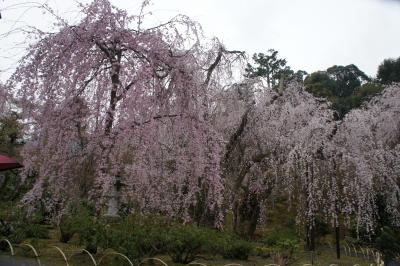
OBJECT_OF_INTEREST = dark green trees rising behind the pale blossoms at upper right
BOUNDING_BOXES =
[245,49,400,119]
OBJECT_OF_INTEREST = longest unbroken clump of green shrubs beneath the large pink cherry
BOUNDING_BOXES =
[60,206,252,264]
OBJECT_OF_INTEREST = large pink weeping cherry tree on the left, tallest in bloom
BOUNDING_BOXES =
[8,0,242,223]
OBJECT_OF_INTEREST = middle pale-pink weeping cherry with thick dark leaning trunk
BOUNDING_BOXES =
[217,81,335,237]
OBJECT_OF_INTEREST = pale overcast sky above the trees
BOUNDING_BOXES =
[0,0,400,79]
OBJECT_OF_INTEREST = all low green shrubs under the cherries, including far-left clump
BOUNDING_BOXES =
[0,202,298,264]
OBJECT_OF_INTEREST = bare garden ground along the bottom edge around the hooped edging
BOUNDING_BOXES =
[0,229,374,266]
